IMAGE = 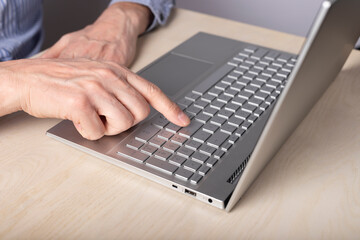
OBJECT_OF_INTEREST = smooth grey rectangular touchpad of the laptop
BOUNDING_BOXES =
[139,54,212,96]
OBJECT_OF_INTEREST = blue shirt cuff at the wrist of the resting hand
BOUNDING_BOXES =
[110,0,175,31]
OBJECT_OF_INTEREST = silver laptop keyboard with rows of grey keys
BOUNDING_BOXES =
[118,46,296,184]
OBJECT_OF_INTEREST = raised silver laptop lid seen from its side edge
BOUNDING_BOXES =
[226,0,360,211]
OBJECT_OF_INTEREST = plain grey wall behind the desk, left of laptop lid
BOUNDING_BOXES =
[176,0,323,36]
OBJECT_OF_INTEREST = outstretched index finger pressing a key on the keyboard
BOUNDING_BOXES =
[127,72,190,127]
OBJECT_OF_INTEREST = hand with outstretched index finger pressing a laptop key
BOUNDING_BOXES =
[0,59,190,140]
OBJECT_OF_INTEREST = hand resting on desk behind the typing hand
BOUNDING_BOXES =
[40,2,152,66]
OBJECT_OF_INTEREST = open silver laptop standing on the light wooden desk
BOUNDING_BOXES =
[47,0,360,211]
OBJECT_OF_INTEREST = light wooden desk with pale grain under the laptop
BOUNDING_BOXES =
[0,9,360,239]
